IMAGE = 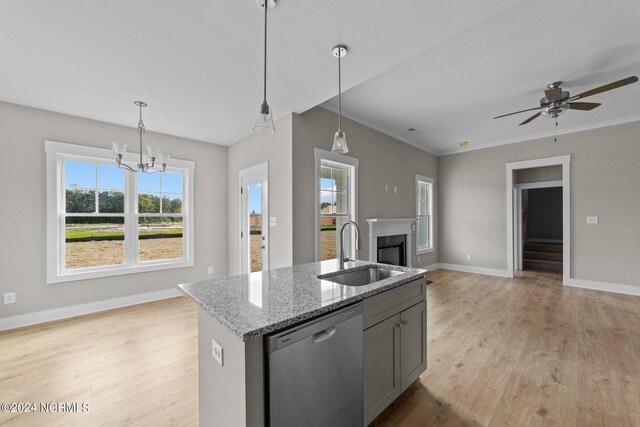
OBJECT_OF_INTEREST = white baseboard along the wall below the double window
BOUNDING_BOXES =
[0,288,182,331]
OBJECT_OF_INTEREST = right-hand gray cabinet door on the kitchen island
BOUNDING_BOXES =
[400,301,427,391]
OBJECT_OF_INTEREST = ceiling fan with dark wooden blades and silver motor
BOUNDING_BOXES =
[494,76,638,126]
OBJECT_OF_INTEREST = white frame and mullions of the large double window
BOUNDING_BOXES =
[45,140,195,284]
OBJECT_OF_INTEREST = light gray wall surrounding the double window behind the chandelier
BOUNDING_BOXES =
[0,102,228,317]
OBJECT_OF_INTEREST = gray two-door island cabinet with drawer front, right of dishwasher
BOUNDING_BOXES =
[363,280,427,425]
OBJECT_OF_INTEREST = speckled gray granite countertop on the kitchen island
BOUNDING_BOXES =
[178,260,427,341]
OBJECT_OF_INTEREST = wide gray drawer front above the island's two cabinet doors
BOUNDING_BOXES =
[362,277,427,329]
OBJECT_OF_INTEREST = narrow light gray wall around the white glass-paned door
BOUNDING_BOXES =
[228,114,293,274]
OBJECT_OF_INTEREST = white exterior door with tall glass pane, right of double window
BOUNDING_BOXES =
[240,162,269,274]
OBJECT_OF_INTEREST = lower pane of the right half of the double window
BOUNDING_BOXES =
[138,217,182,261]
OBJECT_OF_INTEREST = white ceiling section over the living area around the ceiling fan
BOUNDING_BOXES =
[324,0,640,154]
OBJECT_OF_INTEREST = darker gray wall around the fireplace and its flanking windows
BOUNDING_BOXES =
[293,107,438,266]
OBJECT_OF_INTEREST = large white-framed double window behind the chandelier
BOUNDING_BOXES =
[45,141,194,283]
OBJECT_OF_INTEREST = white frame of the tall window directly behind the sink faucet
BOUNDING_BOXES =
[314,148,366,261]
